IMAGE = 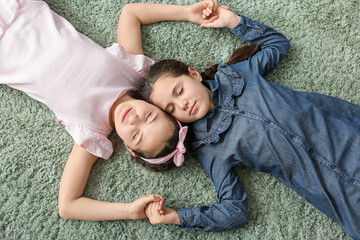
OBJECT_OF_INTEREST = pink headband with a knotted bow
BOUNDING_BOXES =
[140,120,188,167]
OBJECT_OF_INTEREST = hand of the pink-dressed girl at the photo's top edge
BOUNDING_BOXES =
[187,0,228,24]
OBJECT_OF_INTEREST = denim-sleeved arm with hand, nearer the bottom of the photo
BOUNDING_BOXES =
[145,149,248,232]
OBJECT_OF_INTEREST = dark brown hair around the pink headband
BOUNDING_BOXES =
[133,113,180,172]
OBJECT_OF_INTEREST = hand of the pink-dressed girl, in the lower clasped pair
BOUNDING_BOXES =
[129,194,164,219]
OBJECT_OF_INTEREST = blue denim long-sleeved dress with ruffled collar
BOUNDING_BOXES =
[178,16,360,239]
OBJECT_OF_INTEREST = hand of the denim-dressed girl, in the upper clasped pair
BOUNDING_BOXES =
[200,7,241,29]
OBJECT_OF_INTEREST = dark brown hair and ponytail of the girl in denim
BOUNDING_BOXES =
[135,45,260,102]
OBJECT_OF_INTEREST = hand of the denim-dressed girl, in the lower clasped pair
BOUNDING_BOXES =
[145,202,180,225]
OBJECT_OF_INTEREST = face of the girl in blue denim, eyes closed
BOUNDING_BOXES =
[150,67,214,123]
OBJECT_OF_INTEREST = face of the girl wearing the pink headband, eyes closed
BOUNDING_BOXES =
[114,100,175,156]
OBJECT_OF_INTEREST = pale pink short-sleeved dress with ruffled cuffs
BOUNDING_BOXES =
[0,0,153,159]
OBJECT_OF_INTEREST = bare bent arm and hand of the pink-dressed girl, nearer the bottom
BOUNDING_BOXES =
[58,144,162,221]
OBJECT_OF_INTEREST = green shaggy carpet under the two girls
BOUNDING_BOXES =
[0,0,360,239]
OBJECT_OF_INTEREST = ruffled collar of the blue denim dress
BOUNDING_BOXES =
[192,62,244,149]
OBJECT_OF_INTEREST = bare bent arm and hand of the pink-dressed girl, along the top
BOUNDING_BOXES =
[117,0,218,54]
